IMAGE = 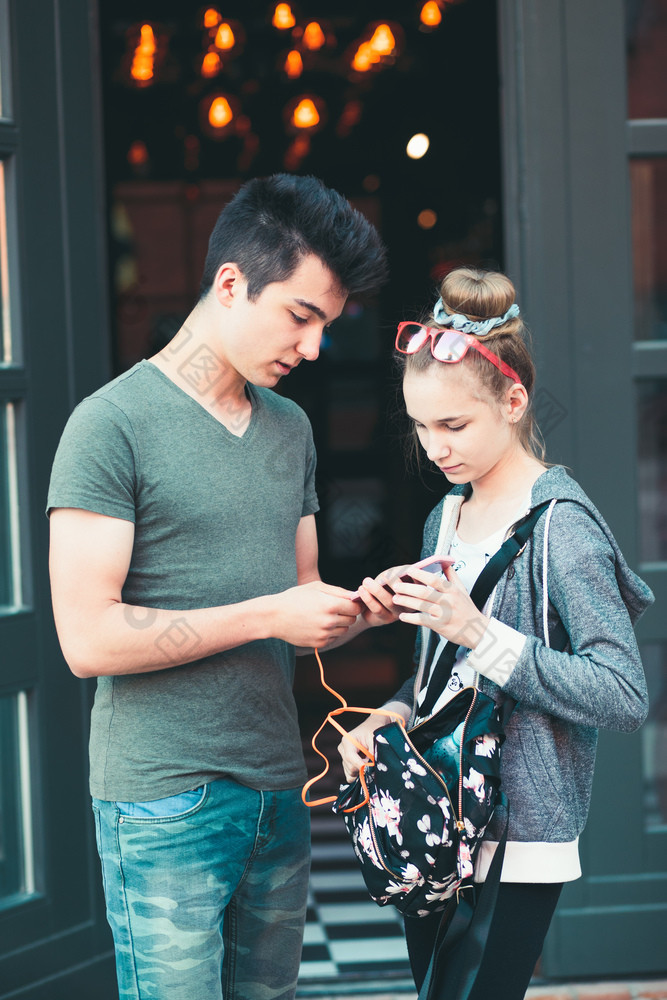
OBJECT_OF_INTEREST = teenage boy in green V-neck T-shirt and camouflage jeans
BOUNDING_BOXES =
[48,175,386,1000]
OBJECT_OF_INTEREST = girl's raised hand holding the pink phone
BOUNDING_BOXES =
[392,566,489,649]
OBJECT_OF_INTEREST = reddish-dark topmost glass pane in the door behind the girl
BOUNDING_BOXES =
[625,0,667,118]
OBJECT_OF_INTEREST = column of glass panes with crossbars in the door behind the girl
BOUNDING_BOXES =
[626,0,667,868]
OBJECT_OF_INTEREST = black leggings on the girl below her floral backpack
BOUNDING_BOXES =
[405,882,563,1000]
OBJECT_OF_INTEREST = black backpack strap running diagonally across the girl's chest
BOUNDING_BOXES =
[418,500,551,718]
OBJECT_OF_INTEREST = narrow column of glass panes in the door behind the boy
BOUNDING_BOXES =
[0,23,36,910]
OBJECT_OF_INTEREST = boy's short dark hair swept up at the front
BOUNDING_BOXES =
[199,174,387,302]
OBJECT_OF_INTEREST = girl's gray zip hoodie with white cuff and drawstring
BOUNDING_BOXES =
[396,466,653,843]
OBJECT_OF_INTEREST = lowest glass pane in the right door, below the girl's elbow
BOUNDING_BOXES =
[642,643,667,830]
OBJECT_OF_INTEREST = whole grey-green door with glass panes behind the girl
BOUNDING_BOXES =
[499,0,667,978]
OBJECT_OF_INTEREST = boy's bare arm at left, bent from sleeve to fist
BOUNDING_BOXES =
[49,508,357,677]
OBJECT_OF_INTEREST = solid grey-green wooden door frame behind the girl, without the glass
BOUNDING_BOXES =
[499,0,667,977]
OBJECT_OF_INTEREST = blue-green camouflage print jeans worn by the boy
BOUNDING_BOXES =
[93,778,310,1000]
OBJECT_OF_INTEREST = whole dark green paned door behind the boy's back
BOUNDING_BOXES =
[0,0,117,1000]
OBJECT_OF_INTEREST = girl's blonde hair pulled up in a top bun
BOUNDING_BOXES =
[397,267,546,463]
